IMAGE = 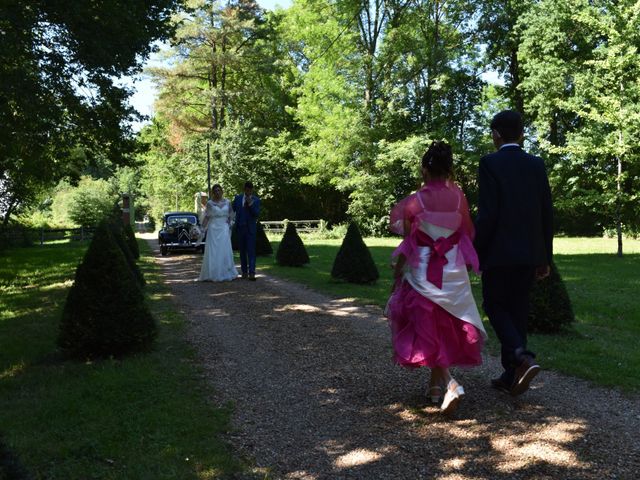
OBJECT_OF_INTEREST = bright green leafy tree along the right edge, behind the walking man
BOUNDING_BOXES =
[521,0,640,256]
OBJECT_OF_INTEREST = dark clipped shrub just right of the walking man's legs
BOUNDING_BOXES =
[528,262,575,333]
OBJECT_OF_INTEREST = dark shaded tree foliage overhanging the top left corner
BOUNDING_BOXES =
[0,0,180,224]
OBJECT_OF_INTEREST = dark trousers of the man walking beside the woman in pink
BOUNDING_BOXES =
[482,266,535,384]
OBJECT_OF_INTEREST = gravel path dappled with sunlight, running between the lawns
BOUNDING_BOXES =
[150,241,640,480]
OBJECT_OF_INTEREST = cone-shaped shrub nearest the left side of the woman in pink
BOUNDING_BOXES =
[331,222,380,283]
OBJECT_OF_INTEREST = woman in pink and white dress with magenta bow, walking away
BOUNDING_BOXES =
[387,142,486,413]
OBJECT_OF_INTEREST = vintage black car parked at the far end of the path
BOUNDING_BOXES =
[158,212,204,255]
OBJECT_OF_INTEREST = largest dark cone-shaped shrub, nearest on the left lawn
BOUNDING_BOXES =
[58,221,156,359]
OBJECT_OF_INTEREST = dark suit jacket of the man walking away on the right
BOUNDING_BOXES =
[474,146,553,270]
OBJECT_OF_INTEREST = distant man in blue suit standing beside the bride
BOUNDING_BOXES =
[232,182,260,281]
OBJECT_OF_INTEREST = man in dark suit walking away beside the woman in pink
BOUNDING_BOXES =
[474,110,553,395]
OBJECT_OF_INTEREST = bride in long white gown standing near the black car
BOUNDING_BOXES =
[198,184,238,282]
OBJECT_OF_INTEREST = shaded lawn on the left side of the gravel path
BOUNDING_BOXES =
[0,242,243,480]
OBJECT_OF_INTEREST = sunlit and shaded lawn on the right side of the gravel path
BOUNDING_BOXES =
[258,237,640,393]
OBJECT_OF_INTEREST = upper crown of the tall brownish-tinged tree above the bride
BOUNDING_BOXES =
[150,0,288,137]
